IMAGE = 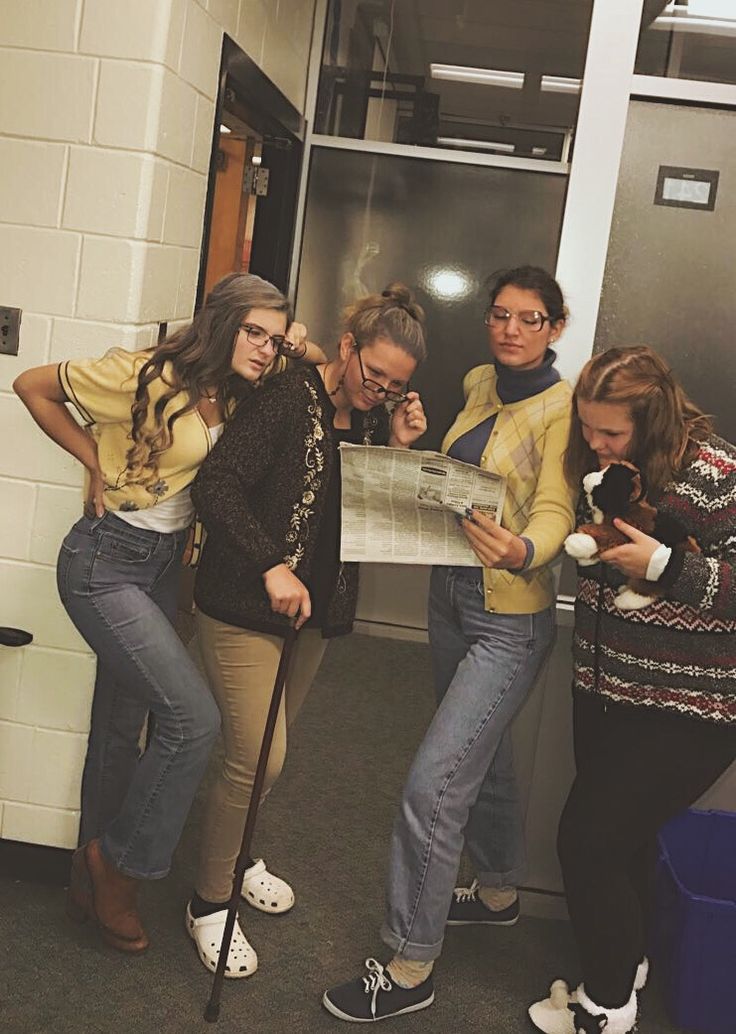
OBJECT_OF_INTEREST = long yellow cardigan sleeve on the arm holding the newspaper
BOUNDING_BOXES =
[521,405,575,571]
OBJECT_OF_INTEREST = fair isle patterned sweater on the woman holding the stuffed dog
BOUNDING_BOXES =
[574,435,736,724]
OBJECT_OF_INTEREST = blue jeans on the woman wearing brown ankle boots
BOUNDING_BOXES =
[57,513,220,879]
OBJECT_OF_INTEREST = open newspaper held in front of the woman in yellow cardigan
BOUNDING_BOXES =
[340,443,505,567]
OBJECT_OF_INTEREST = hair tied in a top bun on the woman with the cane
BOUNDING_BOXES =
[342,281,427,363]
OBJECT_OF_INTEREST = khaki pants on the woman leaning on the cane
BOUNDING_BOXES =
[196,611,327,902]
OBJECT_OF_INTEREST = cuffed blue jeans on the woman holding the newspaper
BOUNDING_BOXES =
[381,568,554,962]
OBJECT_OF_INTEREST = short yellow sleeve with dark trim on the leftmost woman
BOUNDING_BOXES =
[59,348,150,424]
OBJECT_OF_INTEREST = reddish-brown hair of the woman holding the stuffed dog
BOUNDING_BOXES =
[564,344,713,491]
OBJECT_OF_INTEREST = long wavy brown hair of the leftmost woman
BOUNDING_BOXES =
[126,273,292,485]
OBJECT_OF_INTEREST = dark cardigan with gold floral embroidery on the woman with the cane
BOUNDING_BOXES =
[192,365,389,638]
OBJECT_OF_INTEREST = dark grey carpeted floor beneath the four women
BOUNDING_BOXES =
[0,636,690,1034]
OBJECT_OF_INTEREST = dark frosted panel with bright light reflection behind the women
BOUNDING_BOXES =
[297,148,568,449]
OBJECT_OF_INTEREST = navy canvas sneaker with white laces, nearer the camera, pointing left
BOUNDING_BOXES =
[323,959,434,1024]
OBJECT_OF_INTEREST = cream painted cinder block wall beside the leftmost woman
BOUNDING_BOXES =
[0,0,314,847]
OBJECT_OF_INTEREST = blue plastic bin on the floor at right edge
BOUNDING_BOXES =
[654,810,736,1034]
